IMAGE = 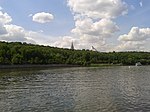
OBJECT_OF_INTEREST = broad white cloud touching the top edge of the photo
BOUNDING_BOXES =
[68,0,128,18]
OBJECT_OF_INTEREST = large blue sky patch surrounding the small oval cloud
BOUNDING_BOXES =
[0,0,74,36]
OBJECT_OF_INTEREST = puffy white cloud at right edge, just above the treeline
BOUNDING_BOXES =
[116,27,150,51]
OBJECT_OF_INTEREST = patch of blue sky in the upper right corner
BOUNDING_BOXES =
[117,0,150,33]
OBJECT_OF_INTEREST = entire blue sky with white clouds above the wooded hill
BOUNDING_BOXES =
[0,0,150,52]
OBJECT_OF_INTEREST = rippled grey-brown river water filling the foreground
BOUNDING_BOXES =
[0,66,150,112]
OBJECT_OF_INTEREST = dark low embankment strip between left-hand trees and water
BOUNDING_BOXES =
[0,64,79,69]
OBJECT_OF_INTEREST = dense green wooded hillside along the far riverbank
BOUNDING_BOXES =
[0,42,150,68]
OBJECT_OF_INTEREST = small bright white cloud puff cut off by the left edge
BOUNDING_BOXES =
[0,11,12,24]
